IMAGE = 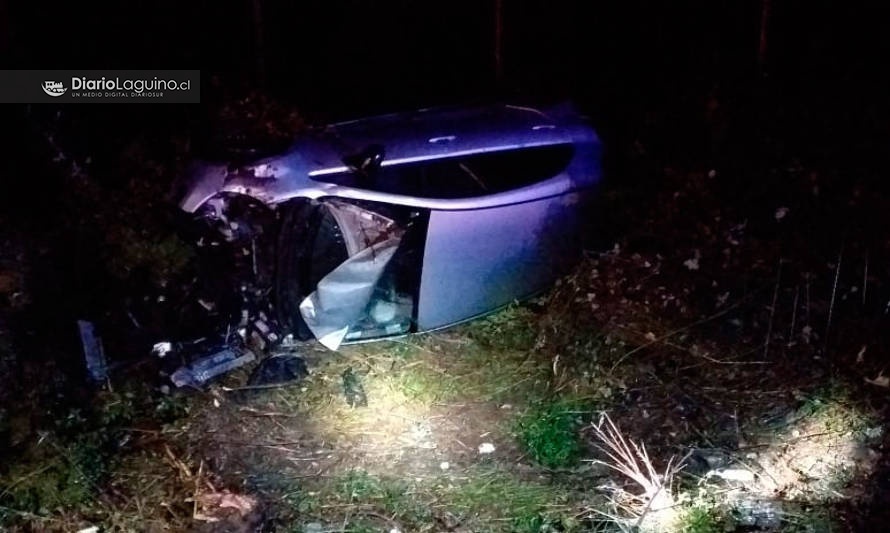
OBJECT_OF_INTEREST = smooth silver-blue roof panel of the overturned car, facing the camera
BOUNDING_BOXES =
[417,192,584,331]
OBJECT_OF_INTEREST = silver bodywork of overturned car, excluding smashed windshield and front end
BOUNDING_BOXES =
[180,104,601,340]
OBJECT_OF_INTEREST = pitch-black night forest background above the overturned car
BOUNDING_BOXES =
[0,0,890,167]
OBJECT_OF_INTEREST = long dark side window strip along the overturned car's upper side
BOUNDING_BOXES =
[317,144,574,199]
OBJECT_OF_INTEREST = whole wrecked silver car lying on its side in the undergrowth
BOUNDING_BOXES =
[180,104,601,349]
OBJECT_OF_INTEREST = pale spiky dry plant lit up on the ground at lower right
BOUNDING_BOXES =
[591,413,689,529]
